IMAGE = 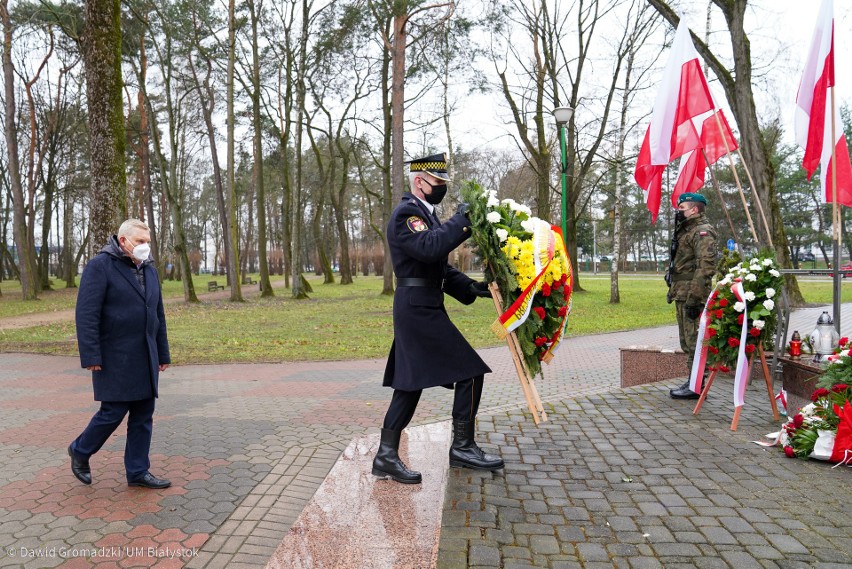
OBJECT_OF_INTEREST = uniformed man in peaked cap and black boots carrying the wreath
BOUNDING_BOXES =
[373,154,503,484]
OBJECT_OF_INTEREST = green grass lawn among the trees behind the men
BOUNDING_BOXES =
[0,274,852,363]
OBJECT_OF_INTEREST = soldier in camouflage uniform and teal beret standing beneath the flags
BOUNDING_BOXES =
[666,193,718,399]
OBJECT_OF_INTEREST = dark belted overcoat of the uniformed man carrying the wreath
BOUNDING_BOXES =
[384,194,491,391]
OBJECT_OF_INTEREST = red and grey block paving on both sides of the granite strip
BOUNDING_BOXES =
[0,306,852,569]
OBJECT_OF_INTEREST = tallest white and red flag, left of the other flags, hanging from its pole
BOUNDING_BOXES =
[633,18,715,222]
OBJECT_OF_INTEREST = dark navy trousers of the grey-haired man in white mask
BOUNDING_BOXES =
[71,397,156,480]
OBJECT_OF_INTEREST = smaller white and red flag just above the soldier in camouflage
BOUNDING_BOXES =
[672,109,739,207]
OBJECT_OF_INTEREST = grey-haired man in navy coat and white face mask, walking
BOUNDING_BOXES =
[68,219,171,488]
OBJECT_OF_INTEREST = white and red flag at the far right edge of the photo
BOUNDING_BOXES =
[795,0,852,207]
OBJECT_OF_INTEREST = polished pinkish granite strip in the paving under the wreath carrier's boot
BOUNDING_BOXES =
[267,421,451,569]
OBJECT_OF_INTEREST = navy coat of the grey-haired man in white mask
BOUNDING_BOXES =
[77,236,171,401]
